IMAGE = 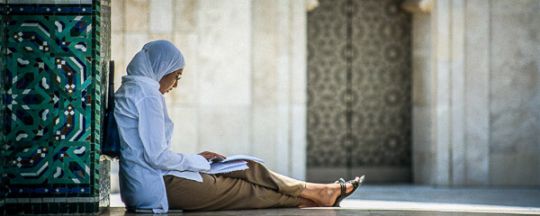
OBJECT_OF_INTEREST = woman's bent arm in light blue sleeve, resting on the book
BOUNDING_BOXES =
[137,97,210,172]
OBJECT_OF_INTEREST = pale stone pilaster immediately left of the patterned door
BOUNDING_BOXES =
[251,0,306,179]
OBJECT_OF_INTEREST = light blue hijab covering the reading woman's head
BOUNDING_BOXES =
[127,40,184,82]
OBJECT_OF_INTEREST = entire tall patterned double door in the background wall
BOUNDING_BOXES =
[308,0,411,172]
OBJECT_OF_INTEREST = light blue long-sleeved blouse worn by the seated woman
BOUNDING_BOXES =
[114,76,210,213]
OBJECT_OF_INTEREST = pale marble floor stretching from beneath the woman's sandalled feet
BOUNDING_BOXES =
[101,185,540,216]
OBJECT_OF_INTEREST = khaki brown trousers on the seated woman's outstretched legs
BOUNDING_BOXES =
[163,161,306,211]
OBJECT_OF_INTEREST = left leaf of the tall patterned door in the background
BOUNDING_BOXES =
[307,0,347,166]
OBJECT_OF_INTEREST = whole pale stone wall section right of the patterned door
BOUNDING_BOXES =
[404,0,540,186]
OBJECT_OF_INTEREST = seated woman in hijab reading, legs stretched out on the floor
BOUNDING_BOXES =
[114,40,363,213]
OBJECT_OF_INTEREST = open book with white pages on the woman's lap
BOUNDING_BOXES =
[207,155,264,174]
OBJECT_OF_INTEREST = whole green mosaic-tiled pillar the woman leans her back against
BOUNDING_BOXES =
[0,1,110,213]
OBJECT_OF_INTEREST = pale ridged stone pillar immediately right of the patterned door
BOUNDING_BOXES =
[404,0,490,185]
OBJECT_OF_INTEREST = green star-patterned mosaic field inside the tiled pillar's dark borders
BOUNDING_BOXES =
[2,13,97,185]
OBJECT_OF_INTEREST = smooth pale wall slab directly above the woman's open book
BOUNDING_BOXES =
[192,0,252,154]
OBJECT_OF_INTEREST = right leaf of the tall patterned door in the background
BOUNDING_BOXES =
[352,0,412,166]
